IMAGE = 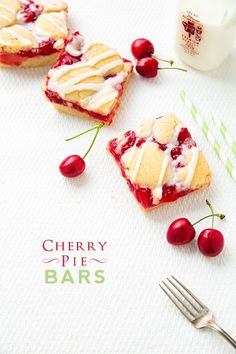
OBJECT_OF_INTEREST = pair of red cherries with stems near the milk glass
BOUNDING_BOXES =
[131,38,187,78]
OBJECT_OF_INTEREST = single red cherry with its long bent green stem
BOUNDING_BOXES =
[59,123,104,178]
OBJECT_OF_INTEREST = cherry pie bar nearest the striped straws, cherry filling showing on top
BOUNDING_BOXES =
[108,114,211,210]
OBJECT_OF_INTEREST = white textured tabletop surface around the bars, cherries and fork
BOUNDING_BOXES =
[0,0,236,354]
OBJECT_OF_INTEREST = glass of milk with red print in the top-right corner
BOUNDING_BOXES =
[176,0,236,71]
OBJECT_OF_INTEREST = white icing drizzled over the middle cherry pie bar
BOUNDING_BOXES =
[48,35,127,110]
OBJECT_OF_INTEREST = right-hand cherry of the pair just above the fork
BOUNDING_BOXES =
[197,229,224,257]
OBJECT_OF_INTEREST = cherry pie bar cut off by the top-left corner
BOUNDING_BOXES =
[0,0,68,67]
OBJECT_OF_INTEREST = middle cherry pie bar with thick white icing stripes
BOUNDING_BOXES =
[43,32,133,125]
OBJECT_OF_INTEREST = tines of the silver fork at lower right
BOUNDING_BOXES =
[159,275,207,321]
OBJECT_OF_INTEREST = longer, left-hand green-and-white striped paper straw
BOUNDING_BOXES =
[180,90,236,182]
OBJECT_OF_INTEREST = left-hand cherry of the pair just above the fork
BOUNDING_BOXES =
[167,218,196,245]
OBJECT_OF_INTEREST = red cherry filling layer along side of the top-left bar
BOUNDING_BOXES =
[0,39,58,65]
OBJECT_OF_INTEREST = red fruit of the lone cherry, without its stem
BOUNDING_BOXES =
[59,155,86,178]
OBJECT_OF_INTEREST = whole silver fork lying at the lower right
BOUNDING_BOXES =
[159,275,236,348]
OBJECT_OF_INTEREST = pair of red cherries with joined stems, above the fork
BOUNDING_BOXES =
[166,200,225,257]
